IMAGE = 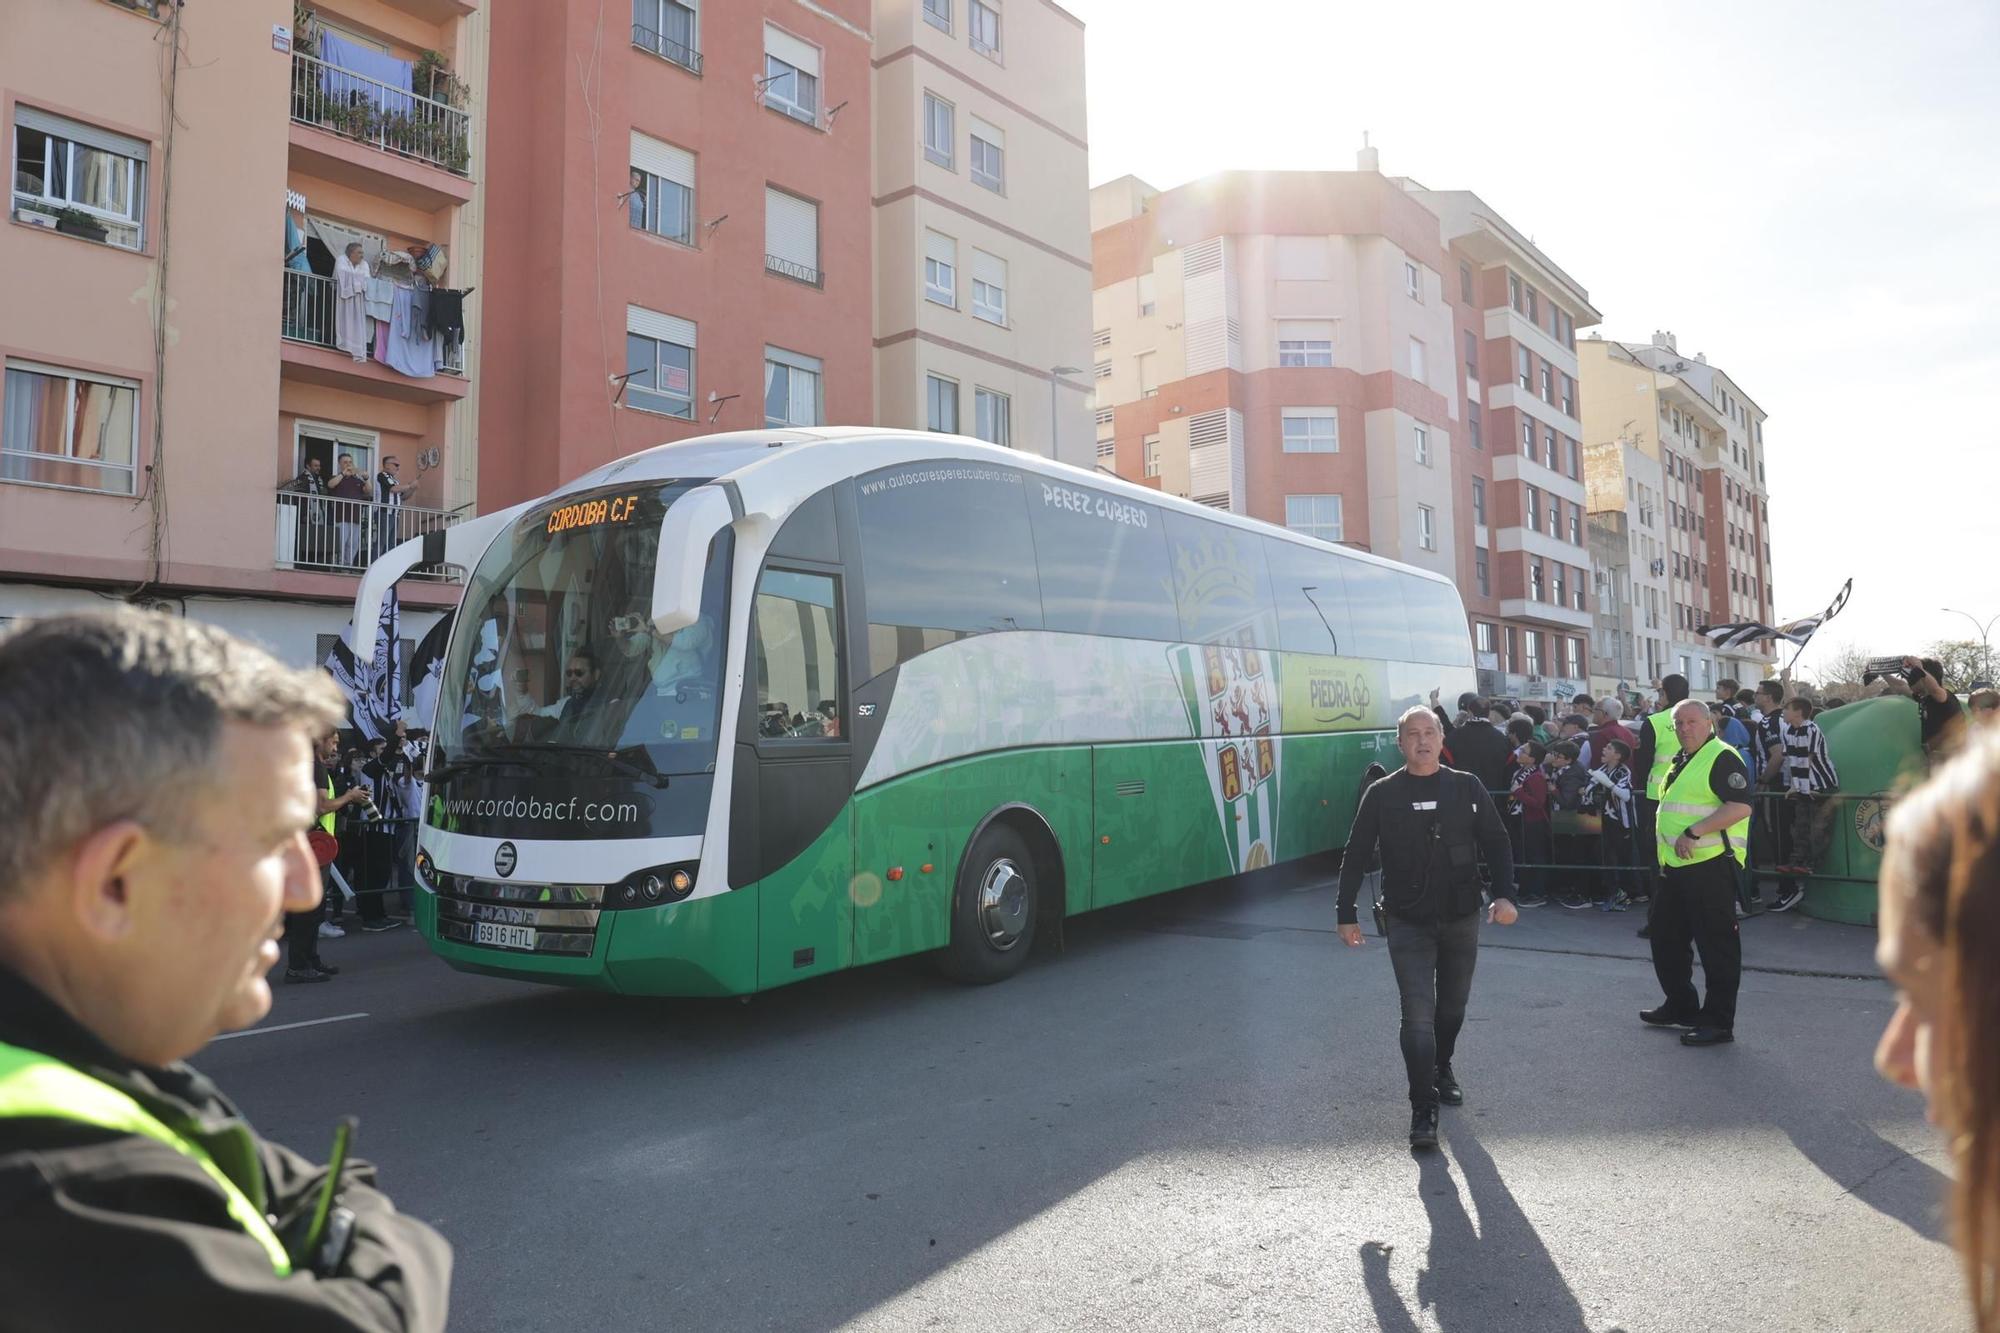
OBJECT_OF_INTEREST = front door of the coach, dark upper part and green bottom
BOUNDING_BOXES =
[730,486,854,987]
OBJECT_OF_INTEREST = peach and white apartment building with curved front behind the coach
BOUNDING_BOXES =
[1092,160,1598,703]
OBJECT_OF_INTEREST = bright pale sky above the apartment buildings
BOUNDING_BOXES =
[1062,0,2000,675]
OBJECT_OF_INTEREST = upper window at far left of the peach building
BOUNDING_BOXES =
[14,106,150,250]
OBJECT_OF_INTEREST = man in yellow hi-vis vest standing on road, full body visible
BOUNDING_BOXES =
[1638,699,1750,1047]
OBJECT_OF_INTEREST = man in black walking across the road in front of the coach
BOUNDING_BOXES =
[1338,709,1518,1149]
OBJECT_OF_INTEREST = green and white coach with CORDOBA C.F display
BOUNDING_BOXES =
[354,428,1474,995]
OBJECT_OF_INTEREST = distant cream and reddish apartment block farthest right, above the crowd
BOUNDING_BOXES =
[1580,332,1778,693]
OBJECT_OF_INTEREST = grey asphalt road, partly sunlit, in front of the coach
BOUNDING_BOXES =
[211,881,1966,1333]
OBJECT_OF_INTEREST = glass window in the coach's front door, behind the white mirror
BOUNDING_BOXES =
[752,568,848,741]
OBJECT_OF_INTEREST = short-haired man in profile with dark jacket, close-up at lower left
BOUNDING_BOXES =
[0,610,452,1333]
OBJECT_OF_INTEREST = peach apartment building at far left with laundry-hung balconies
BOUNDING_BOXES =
[0,0,486,662]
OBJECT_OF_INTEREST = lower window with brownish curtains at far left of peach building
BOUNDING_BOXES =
[0,358,138,494]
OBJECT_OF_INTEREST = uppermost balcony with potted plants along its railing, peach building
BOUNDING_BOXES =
[292,50,472,212]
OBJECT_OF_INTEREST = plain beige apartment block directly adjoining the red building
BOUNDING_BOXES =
[872,0,1092,466]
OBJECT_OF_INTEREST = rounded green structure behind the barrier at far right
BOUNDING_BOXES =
[1800,695,1924,925]
